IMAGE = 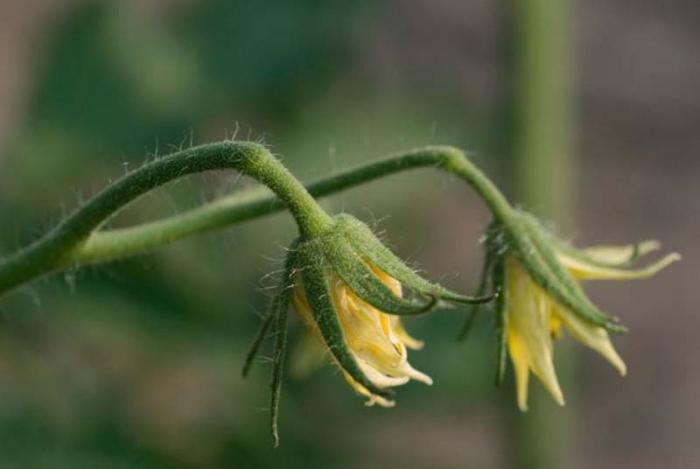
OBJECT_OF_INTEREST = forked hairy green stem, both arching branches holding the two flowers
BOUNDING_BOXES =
[0,142,511,294]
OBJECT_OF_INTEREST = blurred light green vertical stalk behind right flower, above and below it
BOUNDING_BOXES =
[503,0,574,469]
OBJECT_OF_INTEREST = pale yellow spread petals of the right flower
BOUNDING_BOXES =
[505,242,680,411]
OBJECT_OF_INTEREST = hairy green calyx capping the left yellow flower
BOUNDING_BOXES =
[295,215,493,388]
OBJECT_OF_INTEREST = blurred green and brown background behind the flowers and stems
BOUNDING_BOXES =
[0,0,700,469]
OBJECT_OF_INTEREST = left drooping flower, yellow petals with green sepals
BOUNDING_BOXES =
[244,215,493,444]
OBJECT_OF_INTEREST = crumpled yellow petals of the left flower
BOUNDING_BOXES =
[292,266,433,407]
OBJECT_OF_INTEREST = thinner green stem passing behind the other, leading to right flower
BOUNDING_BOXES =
[72,146,511,263]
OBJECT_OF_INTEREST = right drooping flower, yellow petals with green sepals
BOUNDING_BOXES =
[464,211,680,411]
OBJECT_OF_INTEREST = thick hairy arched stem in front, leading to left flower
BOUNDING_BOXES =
[0,141,331,293]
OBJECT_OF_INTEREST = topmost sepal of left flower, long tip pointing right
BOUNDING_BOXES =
[336,214,493,304]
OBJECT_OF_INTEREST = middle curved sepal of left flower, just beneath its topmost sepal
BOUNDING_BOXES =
[323,236,437,316]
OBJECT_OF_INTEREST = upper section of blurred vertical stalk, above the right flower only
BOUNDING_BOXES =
[510,0,574,212]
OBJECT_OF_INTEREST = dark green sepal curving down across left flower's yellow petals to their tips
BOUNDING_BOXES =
[298,240,393,398]
